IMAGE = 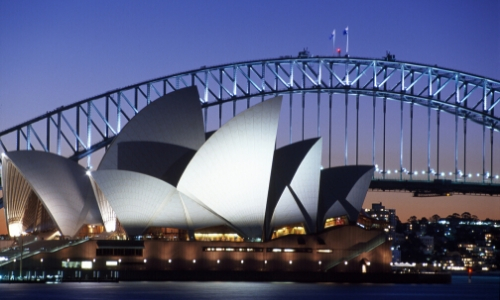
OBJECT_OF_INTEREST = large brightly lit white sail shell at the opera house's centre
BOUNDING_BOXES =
[178,97,281,238]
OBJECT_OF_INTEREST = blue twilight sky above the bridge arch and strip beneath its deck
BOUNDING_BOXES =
[0,0,500,227]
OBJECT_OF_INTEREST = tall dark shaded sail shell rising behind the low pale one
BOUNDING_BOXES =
[98,86,205,184]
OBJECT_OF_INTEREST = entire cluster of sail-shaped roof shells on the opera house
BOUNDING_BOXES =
[2,87,390,276]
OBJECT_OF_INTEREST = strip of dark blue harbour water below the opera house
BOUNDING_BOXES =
[0,276,500,300]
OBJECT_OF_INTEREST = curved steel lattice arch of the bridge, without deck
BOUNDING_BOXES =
[0,56,500,185]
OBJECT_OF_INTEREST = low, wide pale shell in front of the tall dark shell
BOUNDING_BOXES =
[91,170,225,235]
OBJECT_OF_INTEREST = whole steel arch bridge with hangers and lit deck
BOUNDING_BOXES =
[0,52,500,203]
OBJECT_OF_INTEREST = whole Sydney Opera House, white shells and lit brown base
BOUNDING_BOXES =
[0,87,391,278]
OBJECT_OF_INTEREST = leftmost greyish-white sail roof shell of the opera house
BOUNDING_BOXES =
[2,151,102,236]
